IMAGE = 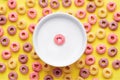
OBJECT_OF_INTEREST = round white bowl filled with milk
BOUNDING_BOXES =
[33,13,87,67]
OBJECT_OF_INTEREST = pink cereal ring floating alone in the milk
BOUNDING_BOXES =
[54,34,65,45]
